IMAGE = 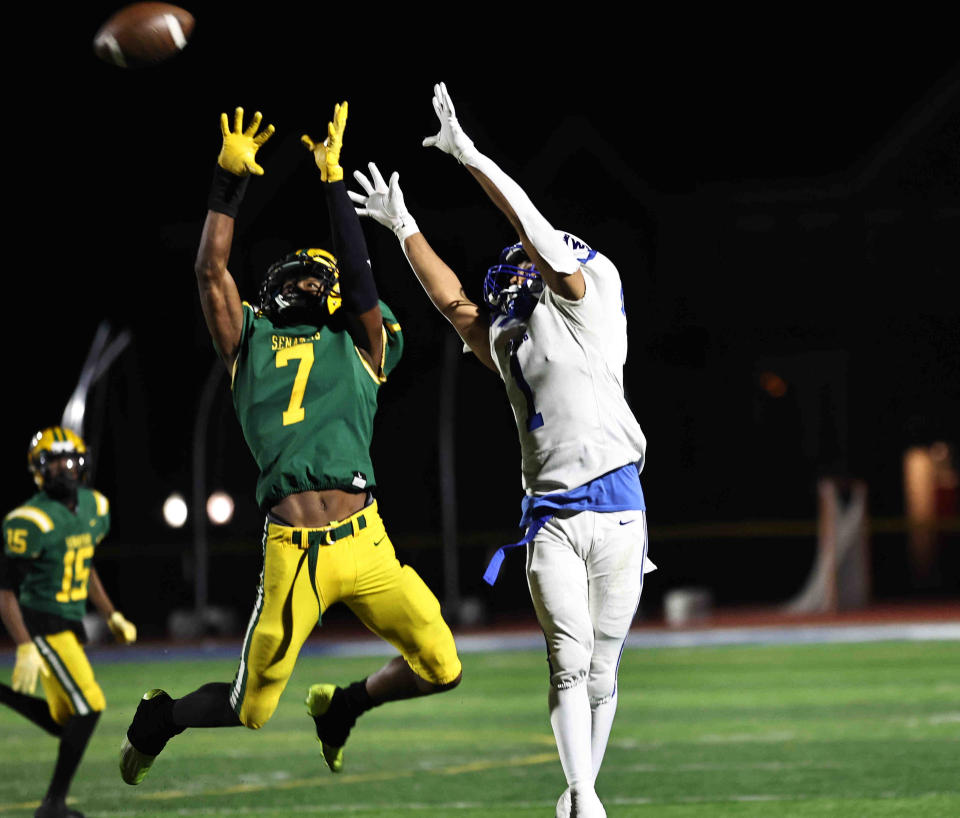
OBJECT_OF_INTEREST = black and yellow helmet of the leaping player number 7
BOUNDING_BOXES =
[258,248,342,324]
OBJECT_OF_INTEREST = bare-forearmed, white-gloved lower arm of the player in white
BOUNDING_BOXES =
[350,162,496,370]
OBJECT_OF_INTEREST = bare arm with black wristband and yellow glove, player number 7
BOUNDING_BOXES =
[194,108,274,369]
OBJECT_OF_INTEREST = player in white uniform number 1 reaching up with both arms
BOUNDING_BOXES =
[350,83,654,818]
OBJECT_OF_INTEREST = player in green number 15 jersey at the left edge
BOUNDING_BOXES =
[0,426,137,818]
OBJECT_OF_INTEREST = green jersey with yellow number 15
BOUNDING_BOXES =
[3,486,110,621]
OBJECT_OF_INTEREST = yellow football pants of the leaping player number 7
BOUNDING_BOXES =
[230,502,461,728]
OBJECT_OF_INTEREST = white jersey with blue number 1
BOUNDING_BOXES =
[490,236,646,494]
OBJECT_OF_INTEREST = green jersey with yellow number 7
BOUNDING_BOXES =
[232,301,403,510]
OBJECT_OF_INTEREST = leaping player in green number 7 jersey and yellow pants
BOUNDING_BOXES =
[120,102,461,784]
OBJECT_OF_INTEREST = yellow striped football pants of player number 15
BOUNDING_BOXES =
[33,631,107,724]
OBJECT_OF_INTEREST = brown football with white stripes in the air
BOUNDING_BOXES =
[93,3,194,68]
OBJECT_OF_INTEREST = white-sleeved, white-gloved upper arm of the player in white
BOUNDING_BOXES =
[423,82,584,300]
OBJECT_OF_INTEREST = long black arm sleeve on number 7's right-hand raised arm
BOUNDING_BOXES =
[323,181,379,315]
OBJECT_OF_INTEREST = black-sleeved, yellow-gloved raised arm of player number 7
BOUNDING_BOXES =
[300,100,383,368]
